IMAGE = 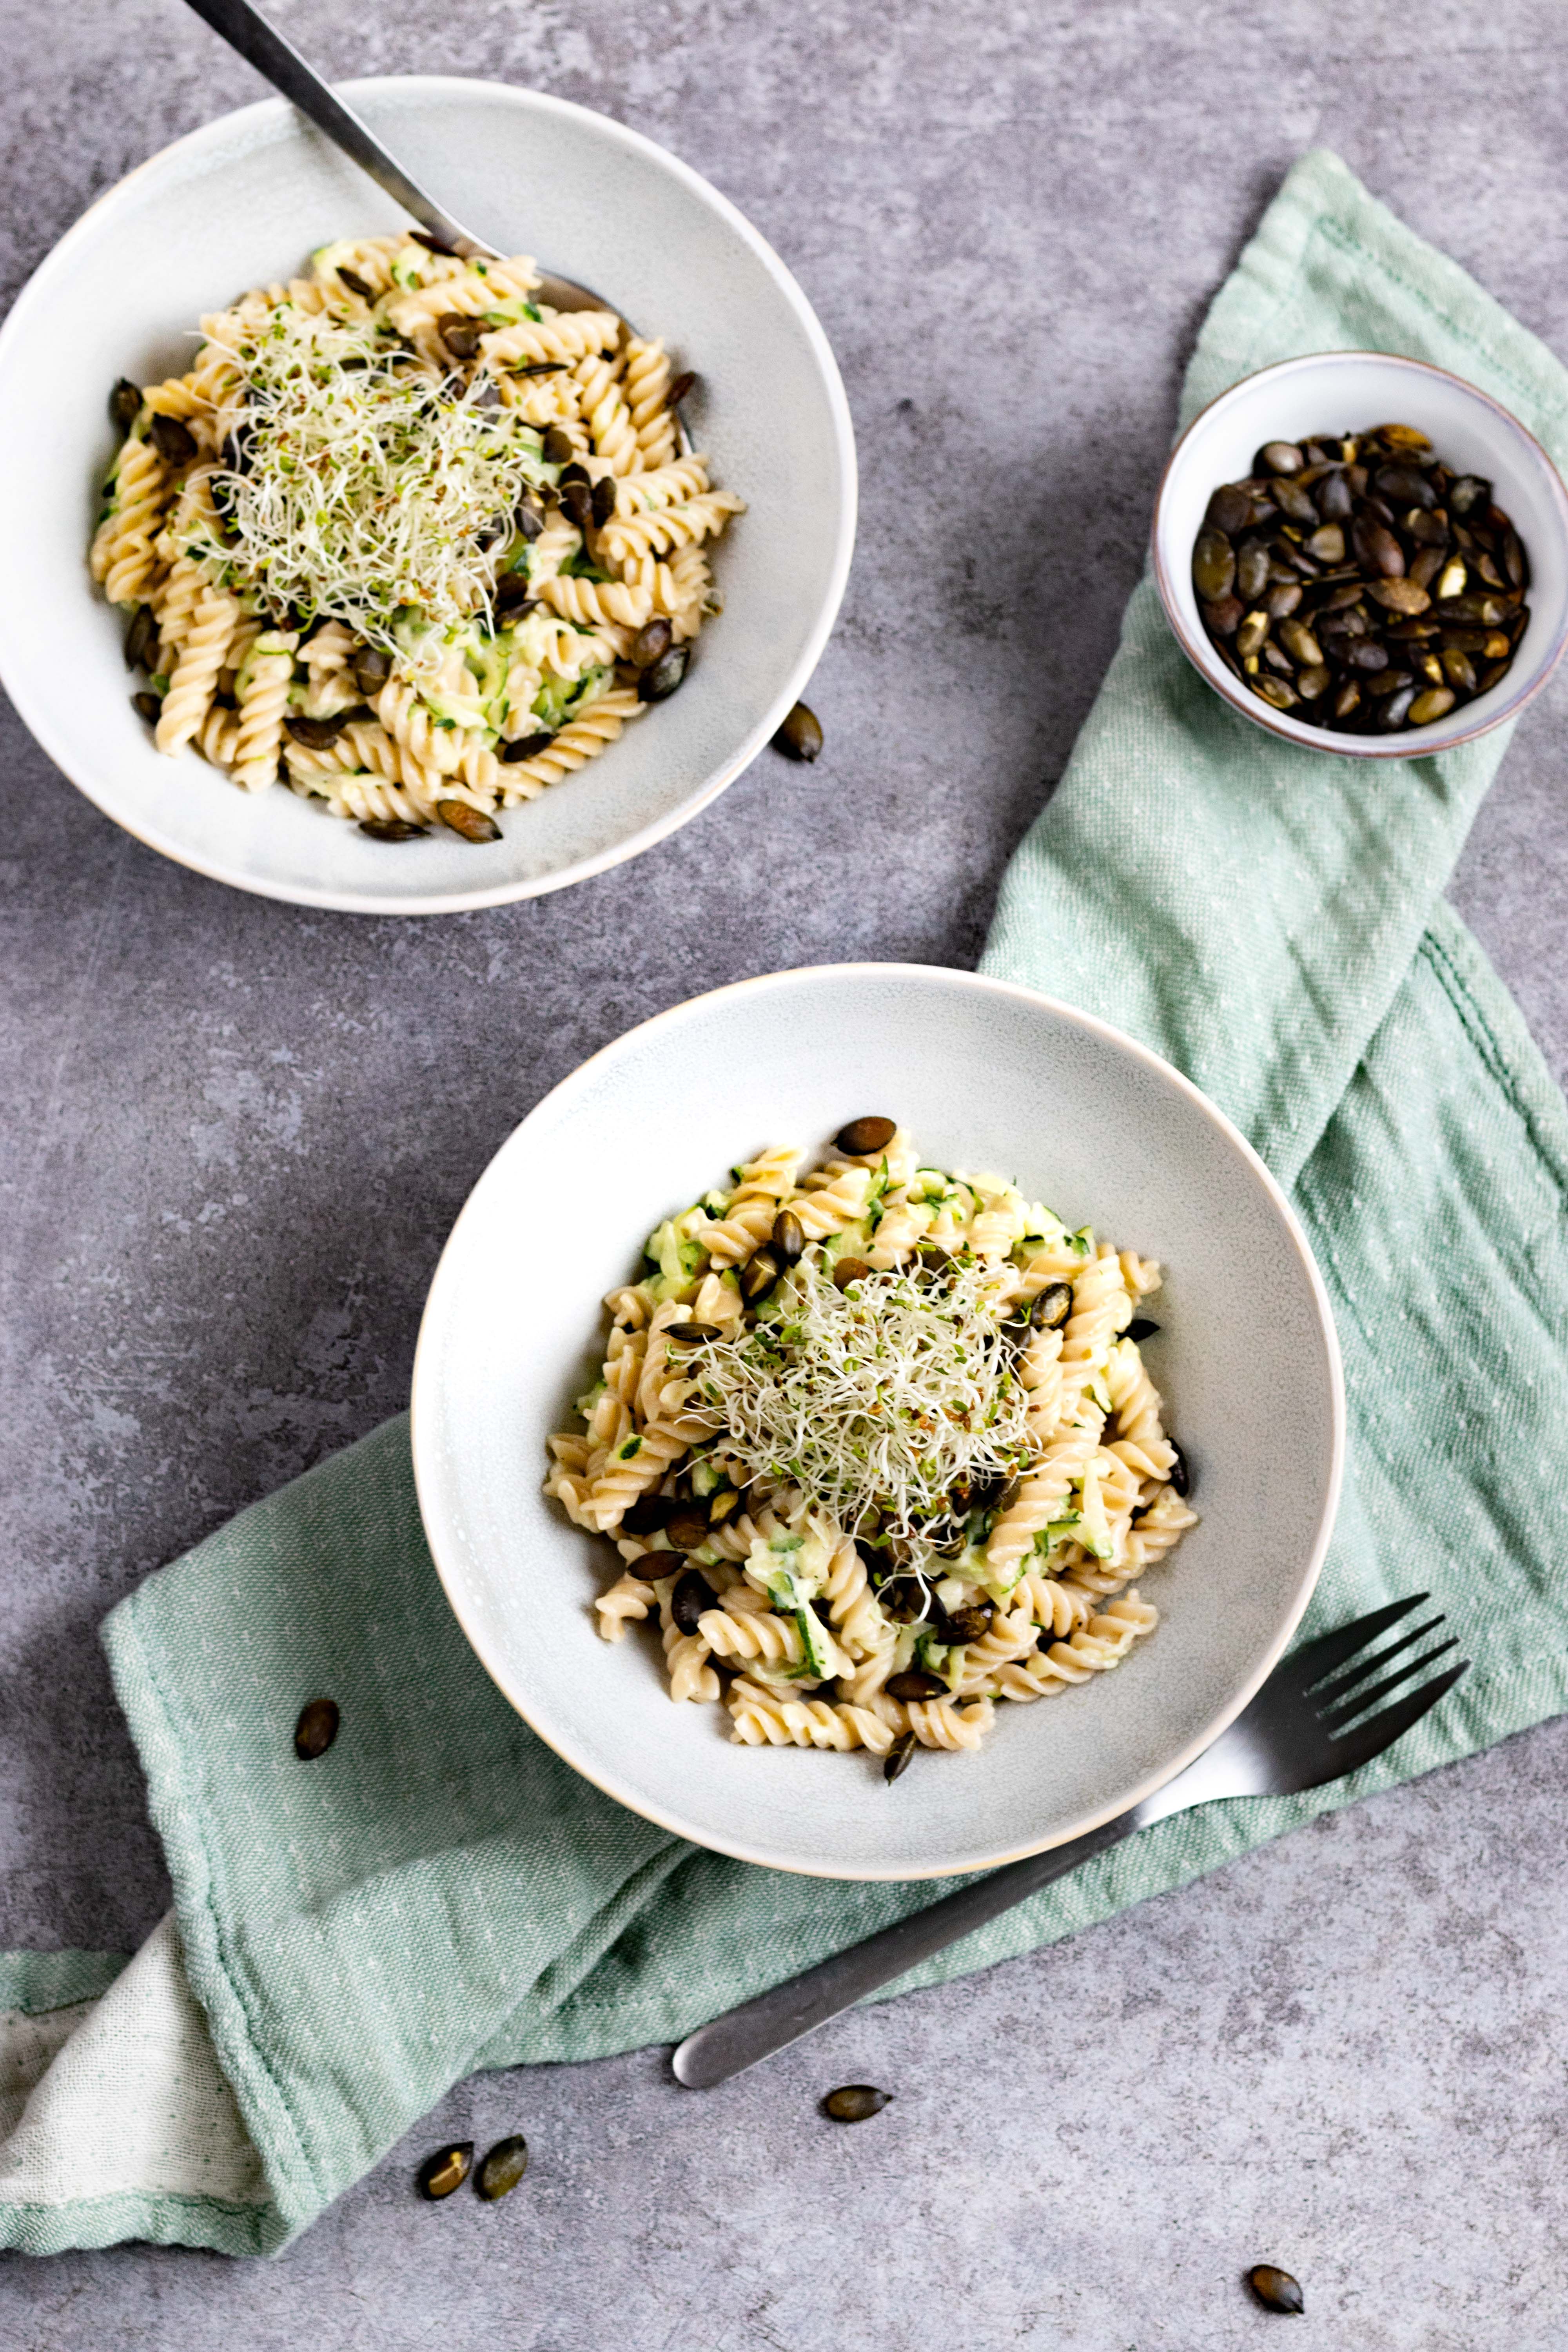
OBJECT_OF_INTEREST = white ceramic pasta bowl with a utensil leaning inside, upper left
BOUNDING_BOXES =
[0,78,856,915]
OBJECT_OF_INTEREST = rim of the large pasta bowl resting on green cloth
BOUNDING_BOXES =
[409,962,1345,1882]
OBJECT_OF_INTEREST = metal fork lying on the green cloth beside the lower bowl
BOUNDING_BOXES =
[675,1592,1469,2091]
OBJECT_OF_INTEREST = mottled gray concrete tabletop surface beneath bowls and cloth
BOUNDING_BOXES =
[0,0,1568,2352]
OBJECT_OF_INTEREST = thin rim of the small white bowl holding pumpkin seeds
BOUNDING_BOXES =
[1150,350,1568,760]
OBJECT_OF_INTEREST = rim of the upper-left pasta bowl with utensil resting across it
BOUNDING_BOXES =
[0,73,858,915]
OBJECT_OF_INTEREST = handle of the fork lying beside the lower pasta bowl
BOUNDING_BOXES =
[672,1809,1140,2091]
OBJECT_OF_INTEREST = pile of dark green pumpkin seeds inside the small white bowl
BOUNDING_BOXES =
[1192,426,1530,734]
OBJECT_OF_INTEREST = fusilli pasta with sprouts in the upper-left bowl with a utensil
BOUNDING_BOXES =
[92,238,743,842]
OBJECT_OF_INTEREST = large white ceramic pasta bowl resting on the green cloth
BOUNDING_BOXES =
[414,964,1342,1879]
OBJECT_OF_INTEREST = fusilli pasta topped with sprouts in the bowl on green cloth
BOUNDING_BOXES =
[545,1120,1194,1778]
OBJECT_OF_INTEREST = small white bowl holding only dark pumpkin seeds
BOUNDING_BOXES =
[1152,350,1568,760]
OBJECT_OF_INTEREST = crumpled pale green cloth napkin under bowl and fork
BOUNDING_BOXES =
[0,155,1568,2253]
